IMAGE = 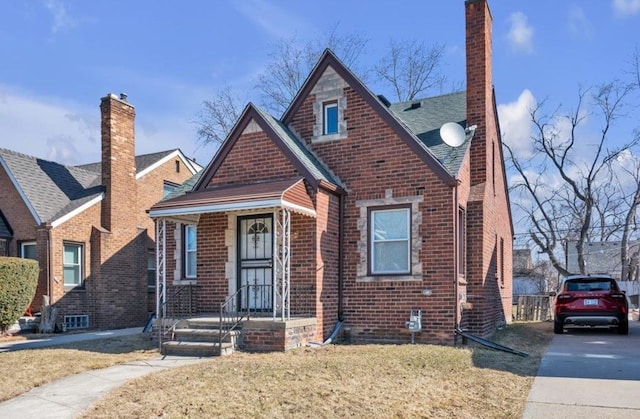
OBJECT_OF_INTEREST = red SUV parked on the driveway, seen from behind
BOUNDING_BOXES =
[553,275,629,335]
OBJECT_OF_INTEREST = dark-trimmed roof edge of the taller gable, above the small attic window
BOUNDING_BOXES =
[282,49,458,184]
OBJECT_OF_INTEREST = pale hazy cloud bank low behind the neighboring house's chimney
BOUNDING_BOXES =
[0,85,210,165]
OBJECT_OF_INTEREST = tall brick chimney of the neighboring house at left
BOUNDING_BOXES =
[100,94,137,232]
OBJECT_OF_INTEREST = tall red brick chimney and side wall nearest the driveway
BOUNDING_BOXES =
[463,1,513,335]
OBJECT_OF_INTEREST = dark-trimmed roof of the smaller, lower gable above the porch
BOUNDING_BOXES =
[193,103,343,190]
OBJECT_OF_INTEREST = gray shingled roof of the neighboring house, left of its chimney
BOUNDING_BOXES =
[0,148,102,222]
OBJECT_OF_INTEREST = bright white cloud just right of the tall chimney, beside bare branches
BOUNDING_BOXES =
[498,89,536,158]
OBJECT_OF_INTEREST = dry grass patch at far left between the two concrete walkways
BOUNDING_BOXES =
[0,334,159,401]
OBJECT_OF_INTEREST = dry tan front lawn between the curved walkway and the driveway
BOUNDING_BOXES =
[84,323,552,418]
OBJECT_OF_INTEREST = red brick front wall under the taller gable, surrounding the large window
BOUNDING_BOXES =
[291,88,456,343]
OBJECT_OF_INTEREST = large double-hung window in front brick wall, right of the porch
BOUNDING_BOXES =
[369,208,411,275]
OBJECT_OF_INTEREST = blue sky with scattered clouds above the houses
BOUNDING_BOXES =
[0,0,640,168]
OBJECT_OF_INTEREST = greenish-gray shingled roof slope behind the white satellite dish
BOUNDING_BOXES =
[389,92,473,176]
